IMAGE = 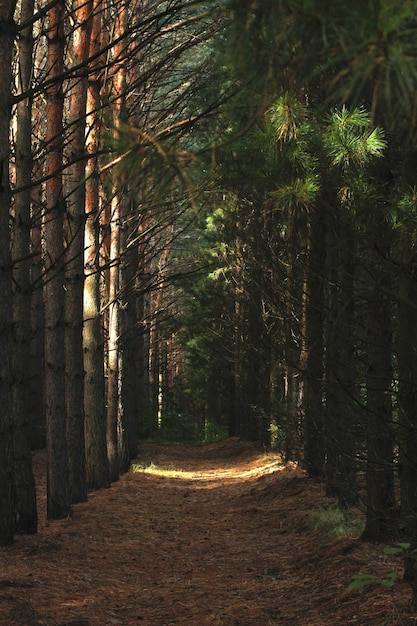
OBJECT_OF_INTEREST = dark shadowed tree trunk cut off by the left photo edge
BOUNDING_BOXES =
[0,0,15,546]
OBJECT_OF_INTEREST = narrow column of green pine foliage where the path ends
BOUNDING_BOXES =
[181,200,237,440]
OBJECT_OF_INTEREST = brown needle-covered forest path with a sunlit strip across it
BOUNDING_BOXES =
[0,438,417,626]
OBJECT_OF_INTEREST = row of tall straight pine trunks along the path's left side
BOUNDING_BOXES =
[0,0,223,543]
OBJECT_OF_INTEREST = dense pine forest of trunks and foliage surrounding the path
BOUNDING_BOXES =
[4,0,417,602]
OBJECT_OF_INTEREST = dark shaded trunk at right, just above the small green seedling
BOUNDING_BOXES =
[362,207,395,542]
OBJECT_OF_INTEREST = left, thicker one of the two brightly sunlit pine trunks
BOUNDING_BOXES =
[83,0,110,490]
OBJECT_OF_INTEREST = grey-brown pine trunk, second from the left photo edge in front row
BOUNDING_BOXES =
[13,0,37,533]
